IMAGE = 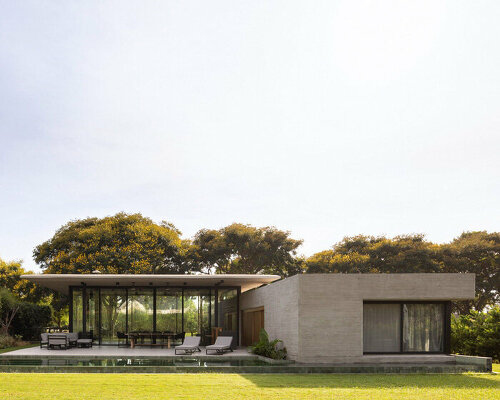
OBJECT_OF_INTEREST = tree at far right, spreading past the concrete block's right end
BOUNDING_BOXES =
[442,231,500,314]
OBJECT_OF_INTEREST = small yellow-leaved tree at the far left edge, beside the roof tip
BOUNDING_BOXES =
[0,258,47,303]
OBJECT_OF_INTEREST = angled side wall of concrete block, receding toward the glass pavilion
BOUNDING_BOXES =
[240,276,299,360]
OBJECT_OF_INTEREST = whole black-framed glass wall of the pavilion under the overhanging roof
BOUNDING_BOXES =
[71,287,239,345]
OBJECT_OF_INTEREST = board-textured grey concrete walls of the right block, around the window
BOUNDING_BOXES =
[241,274,475,363]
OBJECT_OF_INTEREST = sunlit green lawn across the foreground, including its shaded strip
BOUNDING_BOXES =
[0,373,500,400]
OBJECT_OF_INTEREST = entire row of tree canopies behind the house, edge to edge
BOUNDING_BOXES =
[32,213,500,312]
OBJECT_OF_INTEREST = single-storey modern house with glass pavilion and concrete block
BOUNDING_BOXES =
[23,273,475,363]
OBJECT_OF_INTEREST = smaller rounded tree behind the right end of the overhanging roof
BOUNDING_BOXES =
[188,223,303,277]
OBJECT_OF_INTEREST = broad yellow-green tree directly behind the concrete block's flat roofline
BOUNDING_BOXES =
[306,235,441,273]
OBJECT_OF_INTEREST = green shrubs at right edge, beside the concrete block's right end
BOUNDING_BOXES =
[451,306,500,361]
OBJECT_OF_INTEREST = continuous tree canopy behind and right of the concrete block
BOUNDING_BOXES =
[306,232,500,313]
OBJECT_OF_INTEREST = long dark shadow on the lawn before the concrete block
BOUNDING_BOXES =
[241,374,500,389]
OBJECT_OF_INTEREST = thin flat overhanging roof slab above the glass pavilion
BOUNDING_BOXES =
[21,274,281,294]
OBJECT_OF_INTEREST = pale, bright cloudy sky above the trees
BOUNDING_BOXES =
[0,0,500,271]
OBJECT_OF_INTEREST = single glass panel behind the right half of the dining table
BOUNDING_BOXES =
[156,288,183,333]
